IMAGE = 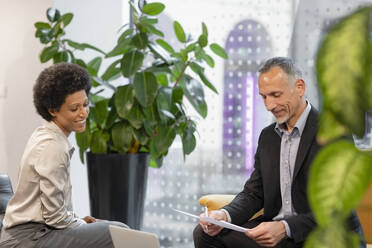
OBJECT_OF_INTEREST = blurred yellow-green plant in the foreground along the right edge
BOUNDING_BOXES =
[305,7,372,248]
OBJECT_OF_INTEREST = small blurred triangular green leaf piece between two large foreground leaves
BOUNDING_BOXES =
[317,108,349,144]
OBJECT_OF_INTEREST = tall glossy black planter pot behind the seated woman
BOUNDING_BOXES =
[87,152,149,230]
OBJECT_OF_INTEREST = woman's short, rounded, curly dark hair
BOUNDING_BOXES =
[34,62,92,121]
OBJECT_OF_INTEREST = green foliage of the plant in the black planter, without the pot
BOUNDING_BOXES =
[35,1,227,166]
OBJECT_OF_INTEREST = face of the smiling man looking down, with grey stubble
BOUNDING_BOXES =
[258,66,305,126]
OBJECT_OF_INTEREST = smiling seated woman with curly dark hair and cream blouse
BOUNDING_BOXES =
[0,63,126,248]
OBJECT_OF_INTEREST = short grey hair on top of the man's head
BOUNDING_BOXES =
[258,57,302,84]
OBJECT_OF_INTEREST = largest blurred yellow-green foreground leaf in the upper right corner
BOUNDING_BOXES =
[316,8,371,137]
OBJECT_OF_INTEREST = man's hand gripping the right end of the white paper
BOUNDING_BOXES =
[245,221,286,247]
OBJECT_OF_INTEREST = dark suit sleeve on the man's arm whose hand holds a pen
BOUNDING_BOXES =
[223,133,264,225]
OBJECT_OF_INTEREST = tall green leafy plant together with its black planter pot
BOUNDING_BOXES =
[35,1,227,228]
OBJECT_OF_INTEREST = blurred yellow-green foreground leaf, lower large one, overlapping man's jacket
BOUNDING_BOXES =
[308,141,372,226]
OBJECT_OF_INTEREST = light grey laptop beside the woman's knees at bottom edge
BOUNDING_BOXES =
[109,225,160,248]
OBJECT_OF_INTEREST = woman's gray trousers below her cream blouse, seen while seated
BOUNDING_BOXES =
[0,221,128,248]
